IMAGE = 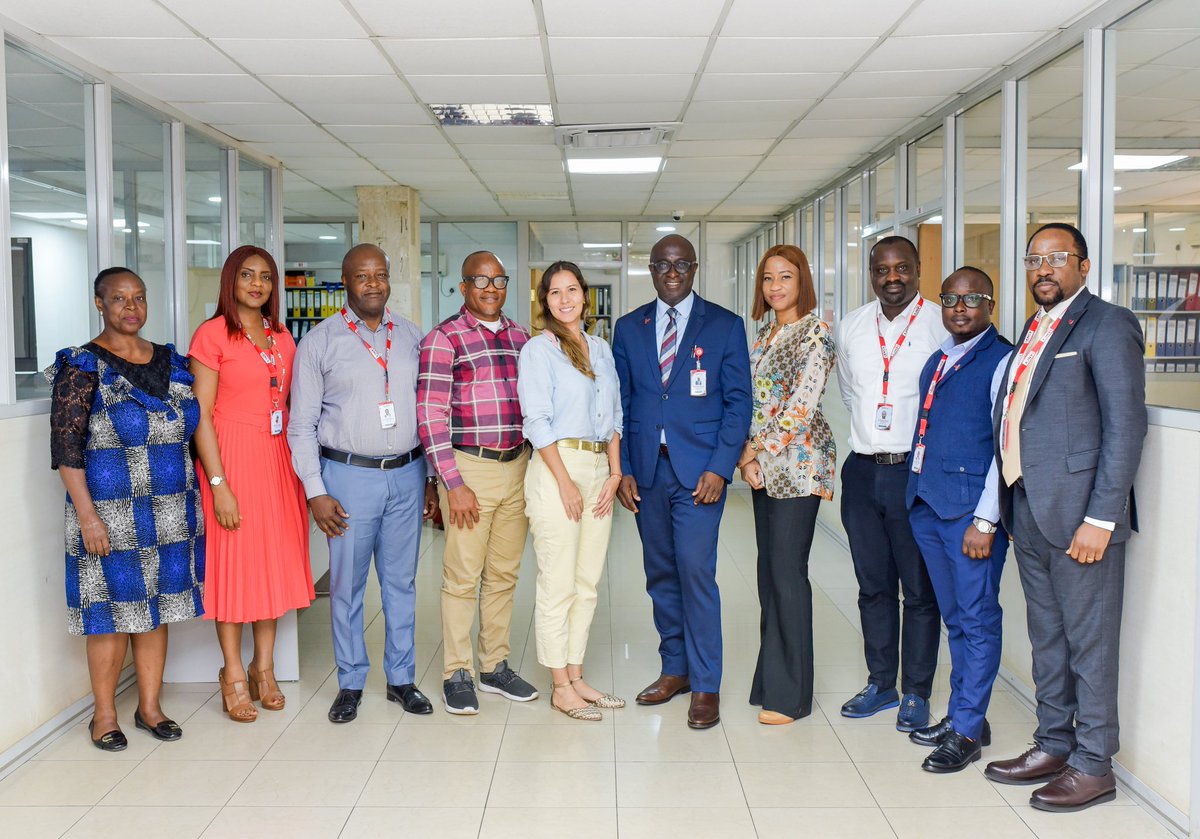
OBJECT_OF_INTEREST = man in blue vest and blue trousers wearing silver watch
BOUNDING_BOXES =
[907,266,1013,773]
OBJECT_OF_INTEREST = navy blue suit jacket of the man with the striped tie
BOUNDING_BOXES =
[612,294,751,486]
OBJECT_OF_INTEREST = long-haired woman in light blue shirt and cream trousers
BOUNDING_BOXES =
[517,262,625,721]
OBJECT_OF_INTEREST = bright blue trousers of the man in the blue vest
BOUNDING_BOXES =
[908,498,1008,739]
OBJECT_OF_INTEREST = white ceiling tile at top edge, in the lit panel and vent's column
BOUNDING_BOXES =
[542,0,725,37]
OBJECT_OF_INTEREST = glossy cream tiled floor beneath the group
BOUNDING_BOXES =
[0,491,1169,839]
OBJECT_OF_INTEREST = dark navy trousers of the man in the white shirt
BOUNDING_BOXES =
[841,453,941,699]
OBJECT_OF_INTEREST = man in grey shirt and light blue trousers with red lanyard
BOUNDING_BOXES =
[288,245,438,723]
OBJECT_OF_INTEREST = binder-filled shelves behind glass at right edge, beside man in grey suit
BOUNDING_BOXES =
[1114,265,1200,378]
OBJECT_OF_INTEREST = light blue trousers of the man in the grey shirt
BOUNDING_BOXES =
[320,457,425,690]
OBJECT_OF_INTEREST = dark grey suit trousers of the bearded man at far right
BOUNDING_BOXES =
[1013,485,1126,775]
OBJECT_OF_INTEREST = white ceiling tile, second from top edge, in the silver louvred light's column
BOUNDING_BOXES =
[378,37,546,76]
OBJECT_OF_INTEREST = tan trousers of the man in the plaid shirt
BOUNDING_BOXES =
[438,451,529,679]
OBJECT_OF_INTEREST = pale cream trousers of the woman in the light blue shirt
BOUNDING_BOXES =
[524,449,612,667]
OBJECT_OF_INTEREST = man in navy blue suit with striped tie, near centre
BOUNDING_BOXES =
[612,235,751,729]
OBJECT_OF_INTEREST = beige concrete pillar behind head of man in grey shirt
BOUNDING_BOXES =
[356,186,421,323]
